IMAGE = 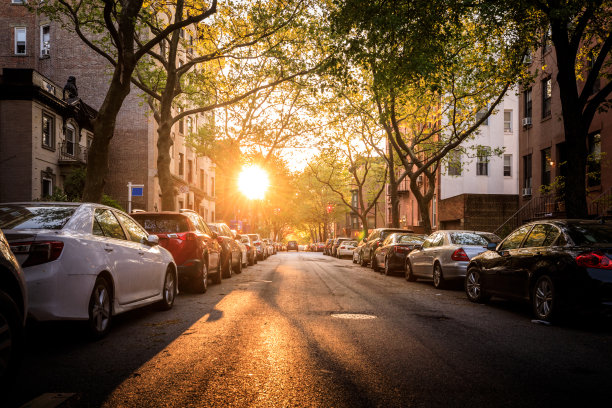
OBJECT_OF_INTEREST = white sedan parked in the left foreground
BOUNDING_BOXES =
[0,202,177,338]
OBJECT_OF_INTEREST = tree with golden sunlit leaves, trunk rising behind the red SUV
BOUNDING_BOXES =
[133,0,322,210]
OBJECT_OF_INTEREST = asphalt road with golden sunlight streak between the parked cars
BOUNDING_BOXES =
[7,252,612,408]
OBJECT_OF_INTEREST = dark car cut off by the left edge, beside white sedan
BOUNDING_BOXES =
[0,231,28,390]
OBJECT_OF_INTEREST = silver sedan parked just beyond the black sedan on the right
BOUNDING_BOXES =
[406,230,501,289]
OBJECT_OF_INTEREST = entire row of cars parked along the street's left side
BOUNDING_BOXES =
[0,202,273,384]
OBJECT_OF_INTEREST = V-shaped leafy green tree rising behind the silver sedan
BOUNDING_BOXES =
[330,0,528,232]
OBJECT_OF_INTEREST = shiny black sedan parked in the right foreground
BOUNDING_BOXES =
[465,220,612,321]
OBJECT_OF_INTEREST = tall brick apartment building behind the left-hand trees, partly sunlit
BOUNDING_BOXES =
[0,0,215,221]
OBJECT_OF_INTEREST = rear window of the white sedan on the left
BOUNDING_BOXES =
[0,205,77,229]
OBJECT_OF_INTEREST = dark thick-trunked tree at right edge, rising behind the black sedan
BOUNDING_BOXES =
[494,0,612,218]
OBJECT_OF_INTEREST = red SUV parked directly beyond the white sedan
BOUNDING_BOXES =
[132,210,221,293]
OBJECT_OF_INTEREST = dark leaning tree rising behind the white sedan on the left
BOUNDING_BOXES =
[38,0,217,202]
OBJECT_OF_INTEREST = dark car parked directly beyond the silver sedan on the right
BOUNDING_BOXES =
[372,232,425,275]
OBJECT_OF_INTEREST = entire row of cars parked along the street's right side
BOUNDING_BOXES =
[334,220,612,321]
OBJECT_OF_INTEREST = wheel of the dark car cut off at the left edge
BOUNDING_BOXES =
[0,291,24,389]
